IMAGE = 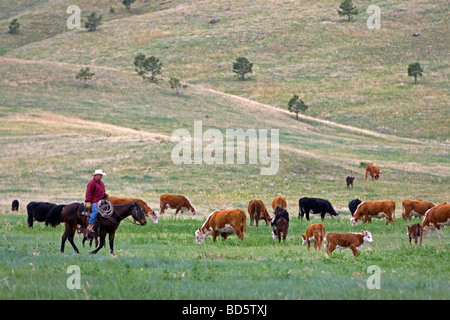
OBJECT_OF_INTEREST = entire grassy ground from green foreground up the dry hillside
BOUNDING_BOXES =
[0,0,450,299]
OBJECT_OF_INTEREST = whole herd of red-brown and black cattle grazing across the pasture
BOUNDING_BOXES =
[11,164,450,257]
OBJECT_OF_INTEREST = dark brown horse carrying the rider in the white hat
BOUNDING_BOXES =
[47,202,147,254]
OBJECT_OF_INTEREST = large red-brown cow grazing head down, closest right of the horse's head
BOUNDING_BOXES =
[195,209,247,243]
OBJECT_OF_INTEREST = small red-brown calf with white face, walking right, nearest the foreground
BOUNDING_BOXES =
[325,231,373,257]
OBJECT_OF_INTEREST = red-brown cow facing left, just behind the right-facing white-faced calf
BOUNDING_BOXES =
[350,200,395,226]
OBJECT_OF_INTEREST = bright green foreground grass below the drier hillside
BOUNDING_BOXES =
[0,211,450,300]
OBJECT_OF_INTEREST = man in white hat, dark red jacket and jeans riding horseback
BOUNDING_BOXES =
[84,169,107,231]
